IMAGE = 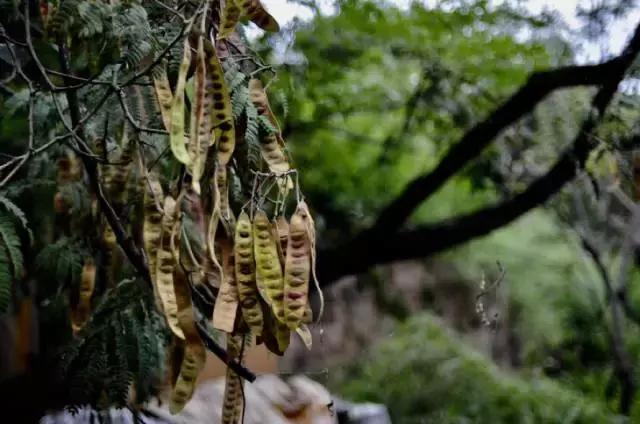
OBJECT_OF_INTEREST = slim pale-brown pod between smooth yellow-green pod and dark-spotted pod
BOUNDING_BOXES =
[189,38,213,194]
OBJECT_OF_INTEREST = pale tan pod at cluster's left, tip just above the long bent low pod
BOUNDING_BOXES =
[156,196,184,339]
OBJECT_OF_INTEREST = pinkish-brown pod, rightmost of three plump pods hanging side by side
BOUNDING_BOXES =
[284,208,311,330]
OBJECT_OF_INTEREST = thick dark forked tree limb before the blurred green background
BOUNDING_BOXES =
[319,26,640,284]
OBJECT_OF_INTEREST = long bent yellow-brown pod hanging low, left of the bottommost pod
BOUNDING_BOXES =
[169,267,206,414]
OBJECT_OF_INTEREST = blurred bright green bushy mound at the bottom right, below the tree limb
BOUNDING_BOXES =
[333,313,622,423]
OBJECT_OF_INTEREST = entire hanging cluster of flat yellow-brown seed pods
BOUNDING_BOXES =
[141,0,323,423]
